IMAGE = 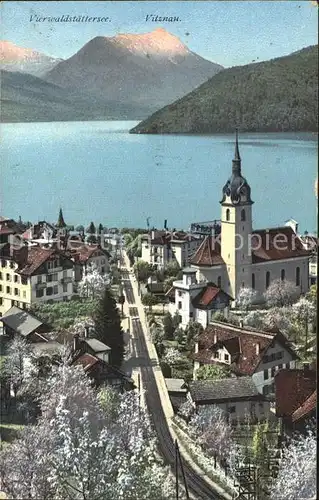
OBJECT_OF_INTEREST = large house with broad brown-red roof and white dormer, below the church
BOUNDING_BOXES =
[191,322,299,396]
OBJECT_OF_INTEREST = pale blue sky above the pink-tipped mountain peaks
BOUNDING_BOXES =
[1,0,318,67]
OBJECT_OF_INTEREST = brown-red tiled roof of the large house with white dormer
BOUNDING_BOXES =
[191,323,284,375]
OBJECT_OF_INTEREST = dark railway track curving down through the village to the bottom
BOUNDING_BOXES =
[123,271,223,500]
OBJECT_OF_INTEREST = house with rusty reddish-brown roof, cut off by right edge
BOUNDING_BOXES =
[275,363,317,435]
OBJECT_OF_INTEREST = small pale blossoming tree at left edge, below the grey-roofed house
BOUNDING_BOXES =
[4,335,32,396]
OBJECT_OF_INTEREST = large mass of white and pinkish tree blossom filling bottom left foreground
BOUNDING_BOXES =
[1,366,173,500]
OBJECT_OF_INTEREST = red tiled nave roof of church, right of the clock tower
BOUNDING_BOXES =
[251,226,310,263]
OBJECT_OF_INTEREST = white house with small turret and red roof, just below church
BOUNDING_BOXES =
[166,267,233,328]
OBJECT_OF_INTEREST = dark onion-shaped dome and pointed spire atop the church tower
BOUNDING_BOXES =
[221,129,253,205]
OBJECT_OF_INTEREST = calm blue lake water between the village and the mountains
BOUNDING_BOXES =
[1,122,317,232]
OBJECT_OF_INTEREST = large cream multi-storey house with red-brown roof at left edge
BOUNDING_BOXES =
[0,244,74,316]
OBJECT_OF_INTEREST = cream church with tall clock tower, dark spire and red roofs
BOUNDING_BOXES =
[190,130,310,302]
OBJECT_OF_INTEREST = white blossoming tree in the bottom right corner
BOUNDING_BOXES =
[271,428,317,500]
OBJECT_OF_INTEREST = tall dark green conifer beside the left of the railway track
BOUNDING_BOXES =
[93,288,124,367]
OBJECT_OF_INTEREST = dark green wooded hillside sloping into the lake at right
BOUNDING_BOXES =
[131,45,318,134]
